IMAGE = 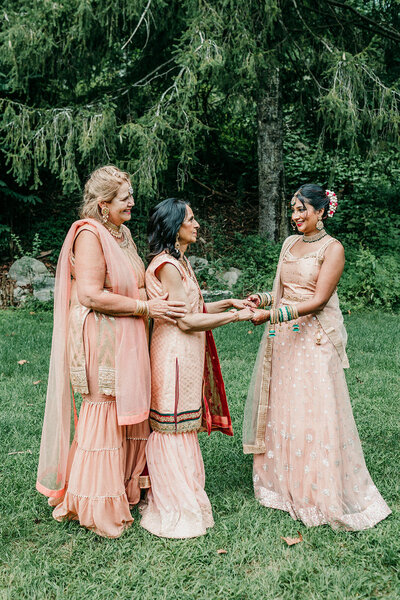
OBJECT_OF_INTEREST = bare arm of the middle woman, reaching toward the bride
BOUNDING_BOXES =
[158,263,252,331]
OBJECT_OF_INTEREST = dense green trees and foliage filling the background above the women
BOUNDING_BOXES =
[0,0,400,304]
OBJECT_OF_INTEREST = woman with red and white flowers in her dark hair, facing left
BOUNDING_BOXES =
[243,184,390,530]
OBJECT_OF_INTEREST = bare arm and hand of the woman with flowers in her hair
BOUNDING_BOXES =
[253,242,344,325]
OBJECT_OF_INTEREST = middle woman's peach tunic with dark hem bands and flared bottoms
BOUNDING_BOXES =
[140,252,219,538]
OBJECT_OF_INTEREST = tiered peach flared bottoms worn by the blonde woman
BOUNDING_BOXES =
[49,313,150,538]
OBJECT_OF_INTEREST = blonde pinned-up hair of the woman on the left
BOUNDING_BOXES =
[79,165,130,221]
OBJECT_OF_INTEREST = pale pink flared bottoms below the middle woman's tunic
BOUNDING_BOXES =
[140,431,214,538]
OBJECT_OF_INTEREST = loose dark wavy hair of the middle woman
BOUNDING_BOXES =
[147,198,188,262]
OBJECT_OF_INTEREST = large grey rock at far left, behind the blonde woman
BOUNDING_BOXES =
[8,256,54,303]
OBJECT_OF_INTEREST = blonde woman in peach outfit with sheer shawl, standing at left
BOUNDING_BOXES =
[36,165,186,538]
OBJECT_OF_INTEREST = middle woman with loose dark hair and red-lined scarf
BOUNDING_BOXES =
[141,198,253,538]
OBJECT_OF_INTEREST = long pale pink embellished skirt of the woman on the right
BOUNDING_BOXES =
[253,315,391,530]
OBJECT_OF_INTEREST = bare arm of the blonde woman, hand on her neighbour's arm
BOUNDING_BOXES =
[75,231,185,322]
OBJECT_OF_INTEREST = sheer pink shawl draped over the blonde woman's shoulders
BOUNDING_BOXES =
[36,219,150,497]
